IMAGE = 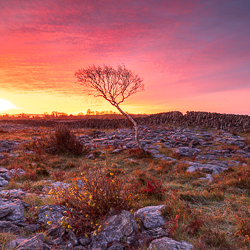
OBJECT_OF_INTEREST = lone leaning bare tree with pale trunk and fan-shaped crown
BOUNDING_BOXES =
[75,65,144,151]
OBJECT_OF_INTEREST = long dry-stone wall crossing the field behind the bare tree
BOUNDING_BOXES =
[0,111,250,132]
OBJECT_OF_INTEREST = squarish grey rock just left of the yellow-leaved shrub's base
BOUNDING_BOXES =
[37,205,66,227]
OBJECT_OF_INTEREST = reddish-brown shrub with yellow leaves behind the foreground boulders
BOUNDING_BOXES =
[54,168,137,235]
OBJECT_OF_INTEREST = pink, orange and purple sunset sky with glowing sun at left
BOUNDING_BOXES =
[0,0,250,115]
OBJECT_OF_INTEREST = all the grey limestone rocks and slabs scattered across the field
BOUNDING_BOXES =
[0,123,250,250]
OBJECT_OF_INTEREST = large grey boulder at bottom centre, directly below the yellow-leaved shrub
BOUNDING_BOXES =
[92,210,138,249]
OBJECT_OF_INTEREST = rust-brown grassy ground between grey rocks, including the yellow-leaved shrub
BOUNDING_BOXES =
[0,124,250,250]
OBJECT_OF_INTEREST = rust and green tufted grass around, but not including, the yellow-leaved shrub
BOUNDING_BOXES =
[0,124,250,250]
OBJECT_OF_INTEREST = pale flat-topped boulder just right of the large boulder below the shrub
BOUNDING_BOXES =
[134,205,165,229]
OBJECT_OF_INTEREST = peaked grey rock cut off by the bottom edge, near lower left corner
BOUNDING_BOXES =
[16,234,51,250]
